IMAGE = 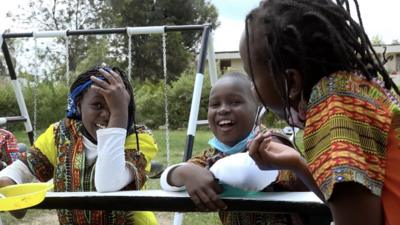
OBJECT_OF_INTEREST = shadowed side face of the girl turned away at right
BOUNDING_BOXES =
[240,32,287,120]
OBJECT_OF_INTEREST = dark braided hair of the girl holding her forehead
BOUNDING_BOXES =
[70,66,137,137]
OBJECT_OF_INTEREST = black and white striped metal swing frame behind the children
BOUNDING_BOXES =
[0,24,217,151]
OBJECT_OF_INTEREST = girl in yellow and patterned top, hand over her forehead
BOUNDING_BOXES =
[0,67,157,225]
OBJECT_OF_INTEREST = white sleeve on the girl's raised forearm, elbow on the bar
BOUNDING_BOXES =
[94,128,133,192]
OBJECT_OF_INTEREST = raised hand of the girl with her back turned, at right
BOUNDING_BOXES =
[249,132,302,170]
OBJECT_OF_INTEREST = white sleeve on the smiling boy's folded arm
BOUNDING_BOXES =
[210,152,278,191]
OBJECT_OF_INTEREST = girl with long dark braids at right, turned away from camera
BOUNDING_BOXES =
[240,0,400,225]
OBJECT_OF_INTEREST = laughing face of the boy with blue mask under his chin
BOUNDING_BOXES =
[207,77,257,146]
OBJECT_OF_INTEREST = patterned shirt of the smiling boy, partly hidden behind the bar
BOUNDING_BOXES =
[189,142,307,225]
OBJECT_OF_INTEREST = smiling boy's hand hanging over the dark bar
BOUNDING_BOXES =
[179,163,227,210]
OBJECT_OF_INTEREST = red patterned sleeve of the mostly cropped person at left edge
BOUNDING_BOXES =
[0,129,19,166]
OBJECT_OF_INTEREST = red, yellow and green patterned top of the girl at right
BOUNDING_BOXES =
[304,72,400,225]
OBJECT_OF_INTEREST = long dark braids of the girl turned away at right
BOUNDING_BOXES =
[246,0,400,100]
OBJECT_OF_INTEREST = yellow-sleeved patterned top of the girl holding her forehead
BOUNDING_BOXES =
[21,119,157,225]
